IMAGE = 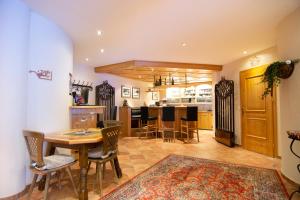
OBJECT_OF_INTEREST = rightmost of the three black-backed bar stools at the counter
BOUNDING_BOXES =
[180,106,199,142]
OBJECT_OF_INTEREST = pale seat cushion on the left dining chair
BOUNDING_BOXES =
[33,154,75,170]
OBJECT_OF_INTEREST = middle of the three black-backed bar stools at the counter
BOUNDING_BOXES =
[162,106,175,142]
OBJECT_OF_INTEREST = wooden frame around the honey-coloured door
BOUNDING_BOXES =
[239,63,279,157]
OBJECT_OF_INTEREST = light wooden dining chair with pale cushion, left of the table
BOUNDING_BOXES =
[23,130,78,200]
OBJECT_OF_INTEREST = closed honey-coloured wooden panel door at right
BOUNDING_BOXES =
[240,65,277,157]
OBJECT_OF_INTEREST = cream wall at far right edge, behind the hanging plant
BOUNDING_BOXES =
[277,8,300,184]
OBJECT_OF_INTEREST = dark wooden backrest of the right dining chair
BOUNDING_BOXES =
[101,126,121,155]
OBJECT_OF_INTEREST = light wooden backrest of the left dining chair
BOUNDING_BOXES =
[23,130,45,167]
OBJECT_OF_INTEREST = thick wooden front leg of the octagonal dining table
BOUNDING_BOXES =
[79,144,88,200]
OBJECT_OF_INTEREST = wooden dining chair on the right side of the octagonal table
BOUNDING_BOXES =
[88,126,121,197]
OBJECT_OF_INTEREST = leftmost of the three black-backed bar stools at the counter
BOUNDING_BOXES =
[139,106,158,138]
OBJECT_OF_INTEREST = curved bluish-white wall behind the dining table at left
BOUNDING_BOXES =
[27,12,73,132]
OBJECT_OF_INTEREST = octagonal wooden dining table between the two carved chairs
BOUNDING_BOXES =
[45,128,102,200]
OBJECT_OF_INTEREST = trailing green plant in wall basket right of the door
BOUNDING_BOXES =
[262,59,299,98]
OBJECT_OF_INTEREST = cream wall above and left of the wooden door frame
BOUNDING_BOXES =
[220,47,280,145]
